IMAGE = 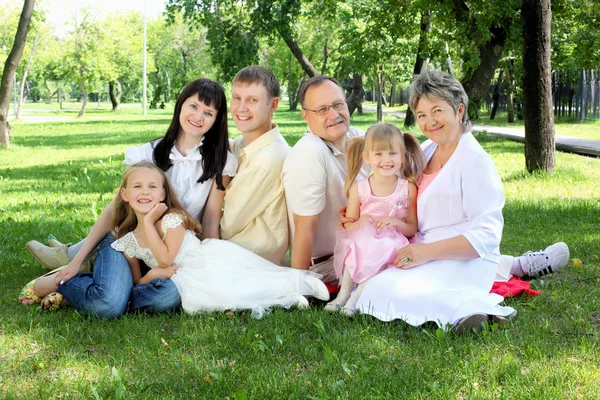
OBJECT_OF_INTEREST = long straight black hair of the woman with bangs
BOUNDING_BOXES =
[153,79,229,190]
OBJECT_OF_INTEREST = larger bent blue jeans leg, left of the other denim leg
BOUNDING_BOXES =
[58,235,133,318]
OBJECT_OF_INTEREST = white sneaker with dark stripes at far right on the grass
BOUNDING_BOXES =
[519,242,569,278]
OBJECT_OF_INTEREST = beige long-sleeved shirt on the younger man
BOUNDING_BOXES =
[221,126,290,265]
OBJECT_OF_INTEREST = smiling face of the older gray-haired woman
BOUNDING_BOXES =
[415,97,465,146]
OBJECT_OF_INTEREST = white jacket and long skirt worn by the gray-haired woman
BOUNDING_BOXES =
[357,132,516,328]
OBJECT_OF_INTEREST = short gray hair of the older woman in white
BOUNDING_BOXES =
[408,70,472,132]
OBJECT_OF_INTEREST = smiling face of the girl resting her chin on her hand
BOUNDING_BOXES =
[121,168,165,214]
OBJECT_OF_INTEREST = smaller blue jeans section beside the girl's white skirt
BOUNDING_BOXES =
[128,278,181,313]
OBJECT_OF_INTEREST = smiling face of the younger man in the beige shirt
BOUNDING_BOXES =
[231,83,279,135]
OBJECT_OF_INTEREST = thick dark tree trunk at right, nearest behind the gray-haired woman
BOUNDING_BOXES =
[521,0,555,172]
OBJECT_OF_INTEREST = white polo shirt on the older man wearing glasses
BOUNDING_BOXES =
[281,127,369,258]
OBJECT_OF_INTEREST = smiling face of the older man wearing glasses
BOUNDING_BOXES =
[302,80,350,147]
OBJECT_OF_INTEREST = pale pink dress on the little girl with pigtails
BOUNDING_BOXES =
[333,178,408,283]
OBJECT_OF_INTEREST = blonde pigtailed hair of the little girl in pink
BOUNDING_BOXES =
[344,123,426,197]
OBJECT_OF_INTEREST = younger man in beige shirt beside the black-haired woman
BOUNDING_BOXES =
[221,66,290,265]
